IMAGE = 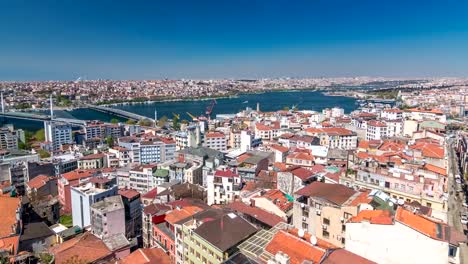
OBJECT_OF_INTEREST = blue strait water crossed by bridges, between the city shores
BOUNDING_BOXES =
[3,91,357,131]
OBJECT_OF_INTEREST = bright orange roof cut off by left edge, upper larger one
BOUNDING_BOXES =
[0,196,20,237]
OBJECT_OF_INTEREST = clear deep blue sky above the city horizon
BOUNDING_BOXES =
[0,0,468,80]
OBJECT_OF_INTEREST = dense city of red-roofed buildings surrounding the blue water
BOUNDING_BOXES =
[0,78,468,264]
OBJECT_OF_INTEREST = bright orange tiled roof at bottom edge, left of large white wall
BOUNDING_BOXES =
[265,230,325,264]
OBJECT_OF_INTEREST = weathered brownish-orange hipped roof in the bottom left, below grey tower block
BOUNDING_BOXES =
[49,232,112,264]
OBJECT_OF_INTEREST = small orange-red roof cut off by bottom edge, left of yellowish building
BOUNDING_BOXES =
[119,248,172,264]
